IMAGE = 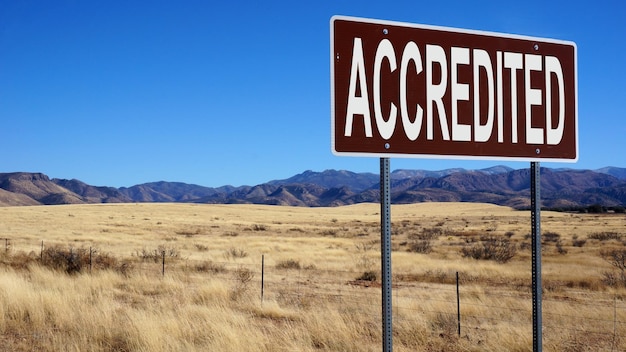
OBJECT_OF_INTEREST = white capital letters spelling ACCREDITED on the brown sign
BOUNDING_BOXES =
[344,37,568,145]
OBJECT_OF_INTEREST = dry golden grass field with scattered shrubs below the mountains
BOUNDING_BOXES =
[0,203,626,352]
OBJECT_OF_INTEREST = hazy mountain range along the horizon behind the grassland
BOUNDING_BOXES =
[0,166,626,209]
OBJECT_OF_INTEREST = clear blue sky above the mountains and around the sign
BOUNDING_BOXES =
[0,0,626,187]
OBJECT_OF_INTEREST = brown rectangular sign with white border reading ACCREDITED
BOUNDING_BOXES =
[330,16,578,162]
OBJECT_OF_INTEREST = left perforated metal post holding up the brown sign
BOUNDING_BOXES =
[380,158,393,352]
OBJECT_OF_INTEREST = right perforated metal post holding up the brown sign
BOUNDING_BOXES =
[530,162,542,352]
